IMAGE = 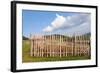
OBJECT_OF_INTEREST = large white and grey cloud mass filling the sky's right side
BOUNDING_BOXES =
[43,14,90,33]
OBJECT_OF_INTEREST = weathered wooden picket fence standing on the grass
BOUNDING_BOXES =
[30,35,91,57]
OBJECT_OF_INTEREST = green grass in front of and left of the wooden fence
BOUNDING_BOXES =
[22,40,90,63]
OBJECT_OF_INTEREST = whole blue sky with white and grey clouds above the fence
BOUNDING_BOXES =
[22,10,91,37]
